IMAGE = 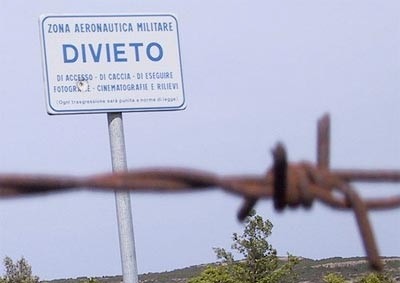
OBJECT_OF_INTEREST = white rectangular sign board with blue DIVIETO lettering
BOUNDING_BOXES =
[40,14,185,114]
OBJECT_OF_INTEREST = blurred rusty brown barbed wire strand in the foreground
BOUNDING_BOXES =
[0,115,400,271]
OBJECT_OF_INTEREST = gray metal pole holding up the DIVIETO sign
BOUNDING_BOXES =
[107,113,139,283]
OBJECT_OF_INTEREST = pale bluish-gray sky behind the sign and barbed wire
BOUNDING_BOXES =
[0,0,400,279]
